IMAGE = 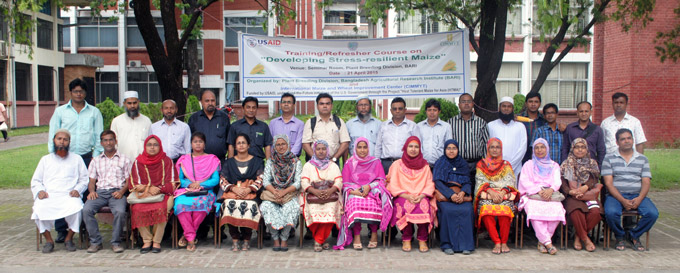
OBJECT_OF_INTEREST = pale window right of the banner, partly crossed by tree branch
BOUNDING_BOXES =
[532,62,588,109]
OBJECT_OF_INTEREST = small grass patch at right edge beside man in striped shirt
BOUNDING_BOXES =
[645,149,680,190]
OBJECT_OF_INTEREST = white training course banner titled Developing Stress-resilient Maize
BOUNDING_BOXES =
[239,29,470,100]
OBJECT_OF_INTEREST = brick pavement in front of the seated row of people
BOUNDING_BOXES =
[0,189,680,272]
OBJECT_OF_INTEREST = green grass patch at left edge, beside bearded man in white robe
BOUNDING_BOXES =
[0,144,47,189]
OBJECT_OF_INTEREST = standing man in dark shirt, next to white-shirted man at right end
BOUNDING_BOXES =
[561,101,606,168]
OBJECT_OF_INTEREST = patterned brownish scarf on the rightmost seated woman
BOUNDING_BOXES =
[561,137,600,186]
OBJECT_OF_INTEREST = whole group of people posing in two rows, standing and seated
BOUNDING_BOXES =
[31,79,658,255]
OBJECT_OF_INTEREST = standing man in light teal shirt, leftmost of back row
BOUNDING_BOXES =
[47,76,104,166]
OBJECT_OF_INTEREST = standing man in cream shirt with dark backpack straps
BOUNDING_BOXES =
[302,93,350,165]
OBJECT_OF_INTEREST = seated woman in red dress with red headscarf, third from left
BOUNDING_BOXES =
[128,135,178,254]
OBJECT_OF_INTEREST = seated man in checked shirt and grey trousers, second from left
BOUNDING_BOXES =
[83,130,132,253]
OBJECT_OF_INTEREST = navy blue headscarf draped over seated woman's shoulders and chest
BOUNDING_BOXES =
[432,139,470,186]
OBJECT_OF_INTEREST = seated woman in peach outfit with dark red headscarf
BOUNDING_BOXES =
[387,136,437,252]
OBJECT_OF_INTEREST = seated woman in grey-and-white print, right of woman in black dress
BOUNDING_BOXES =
[260,134,302,251]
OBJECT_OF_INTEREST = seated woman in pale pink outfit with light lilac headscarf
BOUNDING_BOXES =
[519,138,566,255]
